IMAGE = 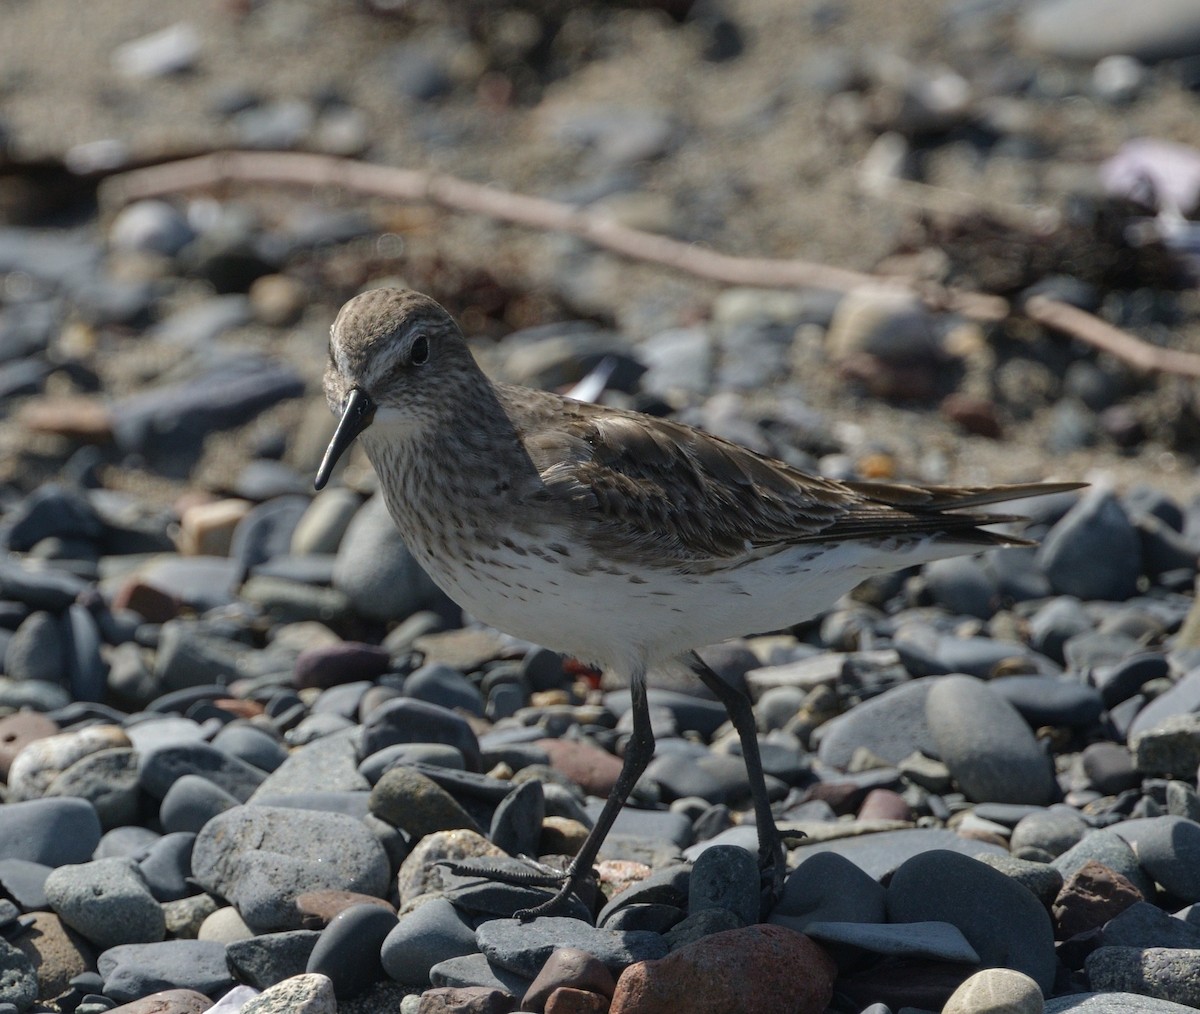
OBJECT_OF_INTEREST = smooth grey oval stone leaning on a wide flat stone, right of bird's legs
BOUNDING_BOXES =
[925,676,1058,805]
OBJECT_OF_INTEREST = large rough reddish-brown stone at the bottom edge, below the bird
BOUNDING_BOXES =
[610,925,838,1014]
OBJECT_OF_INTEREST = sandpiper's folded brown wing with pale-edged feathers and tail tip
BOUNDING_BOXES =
[511,386,1078,562]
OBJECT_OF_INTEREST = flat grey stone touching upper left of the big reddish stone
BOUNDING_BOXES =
[475,916,667,979]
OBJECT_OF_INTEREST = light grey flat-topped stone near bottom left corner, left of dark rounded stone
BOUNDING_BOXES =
[96,940,234,1001]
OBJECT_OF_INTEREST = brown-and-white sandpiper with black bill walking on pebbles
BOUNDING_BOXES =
[316,288,1079,920]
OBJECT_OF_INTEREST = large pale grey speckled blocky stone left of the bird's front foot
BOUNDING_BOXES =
[192,805,390,932]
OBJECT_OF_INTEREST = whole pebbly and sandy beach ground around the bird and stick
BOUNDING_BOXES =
[0,0,1200,1014]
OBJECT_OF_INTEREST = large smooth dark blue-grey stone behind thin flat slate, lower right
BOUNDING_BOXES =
[887,851,1056,994]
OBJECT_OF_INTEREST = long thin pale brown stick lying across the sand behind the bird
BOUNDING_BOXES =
[100,151,1200,377]
